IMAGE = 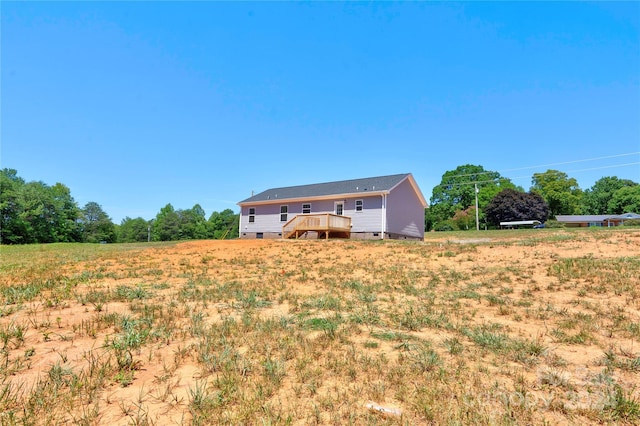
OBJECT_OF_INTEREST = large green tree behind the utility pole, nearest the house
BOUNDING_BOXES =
[426,164,515,230]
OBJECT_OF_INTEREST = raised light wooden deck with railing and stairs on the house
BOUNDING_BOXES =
[282,213,351,239]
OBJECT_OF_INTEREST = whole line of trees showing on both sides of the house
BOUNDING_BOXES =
[0,164,640,244]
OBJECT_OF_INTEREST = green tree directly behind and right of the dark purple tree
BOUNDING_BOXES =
[531,170,583,216]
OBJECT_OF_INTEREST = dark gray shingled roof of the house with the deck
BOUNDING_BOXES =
[238,173,409,204]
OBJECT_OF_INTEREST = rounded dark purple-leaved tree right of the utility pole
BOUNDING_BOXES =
[485,189,549,225]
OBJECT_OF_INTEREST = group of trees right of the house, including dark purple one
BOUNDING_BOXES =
[425,164,640,231]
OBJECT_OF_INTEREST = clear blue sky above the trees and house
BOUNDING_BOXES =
[0,1,640,223]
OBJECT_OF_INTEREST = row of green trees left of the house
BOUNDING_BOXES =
[0,168,238,244]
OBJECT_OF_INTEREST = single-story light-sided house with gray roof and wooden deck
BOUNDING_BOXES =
[238,173,427,240]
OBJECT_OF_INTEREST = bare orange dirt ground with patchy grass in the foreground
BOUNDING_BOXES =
[0,229,640,425]
